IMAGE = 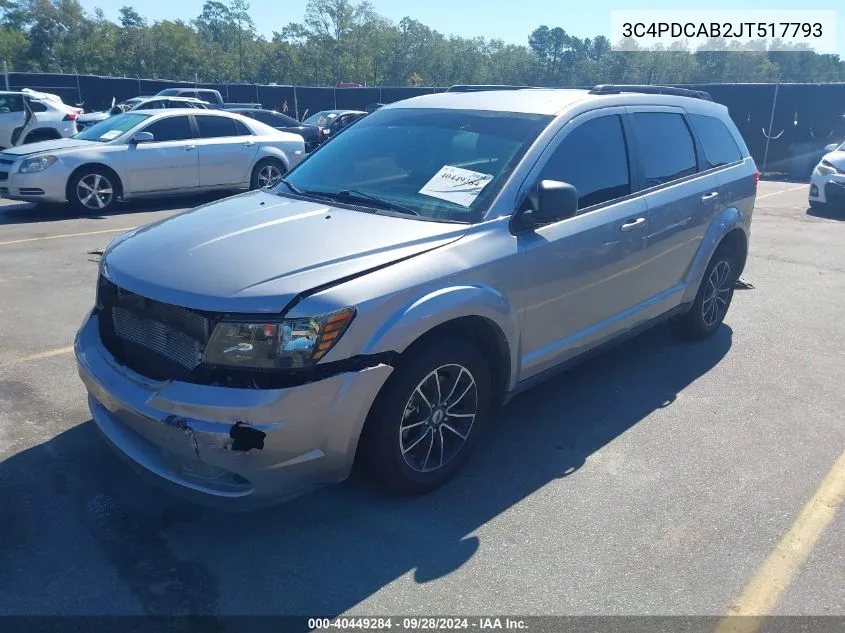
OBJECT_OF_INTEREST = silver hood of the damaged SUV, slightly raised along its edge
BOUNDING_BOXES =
[102,191,469,313]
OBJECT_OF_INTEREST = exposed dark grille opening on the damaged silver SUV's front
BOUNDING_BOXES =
[97,276,214,380]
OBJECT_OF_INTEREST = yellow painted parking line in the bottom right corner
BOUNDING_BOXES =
[716,444,845,633]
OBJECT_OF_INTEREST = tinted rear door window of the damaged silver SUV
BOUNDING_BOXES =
[630,112,698,189]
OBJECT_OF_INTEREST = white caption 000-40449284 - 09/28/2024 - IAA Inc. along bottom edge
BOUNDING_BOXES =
[308,616,528,631]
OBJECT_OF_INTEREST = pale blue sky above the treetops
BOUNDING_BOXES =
[81,0,845,57]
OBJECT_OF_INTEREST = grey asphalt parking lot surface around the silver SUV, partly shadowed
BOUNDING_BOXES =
[0,182,845,616]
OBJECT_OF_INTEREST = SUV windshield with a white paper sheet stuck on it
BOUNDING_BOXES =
[276,108,552,222]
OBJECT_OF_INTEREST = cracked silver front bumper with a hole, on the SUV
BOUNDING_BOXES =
[74,315,393,509]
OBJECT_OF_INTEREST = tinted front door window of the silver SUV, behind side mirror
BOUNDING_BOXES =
[540,114,631,209]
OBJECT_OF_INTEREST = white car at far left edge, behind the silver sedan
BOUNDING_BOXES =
[0,90,79,149]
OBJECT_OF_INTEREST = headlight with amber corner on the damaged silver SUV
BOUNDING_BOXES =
[203,308,355,369]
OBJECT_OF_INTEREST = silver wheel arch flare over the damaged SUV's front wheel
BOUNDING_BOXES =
[363,284,519,386]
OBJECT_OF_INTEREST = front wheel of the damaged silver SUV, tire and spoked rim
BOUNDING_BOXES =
[357,338,491,495]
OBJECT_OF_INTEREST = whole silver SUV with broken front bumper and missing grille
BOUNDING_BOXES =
[76,86,758,507]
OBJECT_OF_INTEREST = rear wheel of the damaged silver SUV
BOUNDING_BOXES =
[670,244,739,341]
